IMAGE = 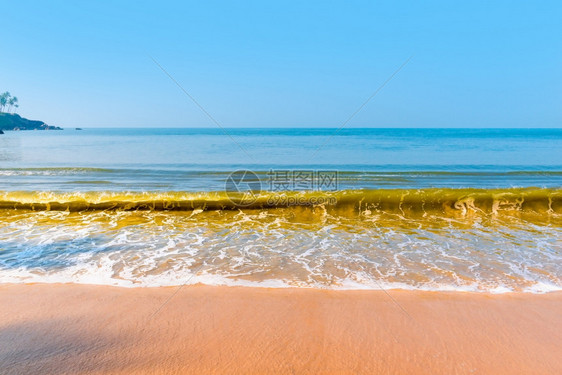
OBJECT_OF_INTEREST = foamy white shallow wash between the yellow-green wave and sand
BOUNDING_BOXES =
[0,212,562,293]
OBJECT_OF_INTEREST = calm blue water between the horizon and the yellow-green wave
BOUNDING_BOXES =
[0,129,562,191]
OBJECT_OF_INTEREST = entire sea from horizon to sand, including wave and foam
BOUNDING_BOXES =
[0,128,562,293]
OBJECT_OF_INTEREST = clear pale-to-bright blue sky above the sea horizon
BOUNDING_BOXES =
[0,0,562,127]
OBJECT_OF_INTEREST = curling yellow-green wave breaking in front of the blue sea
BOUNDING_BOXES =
[0,188,562,215]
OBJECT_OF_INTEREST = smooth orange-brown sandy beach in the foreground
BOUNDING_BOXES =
[0,284,562,374]
